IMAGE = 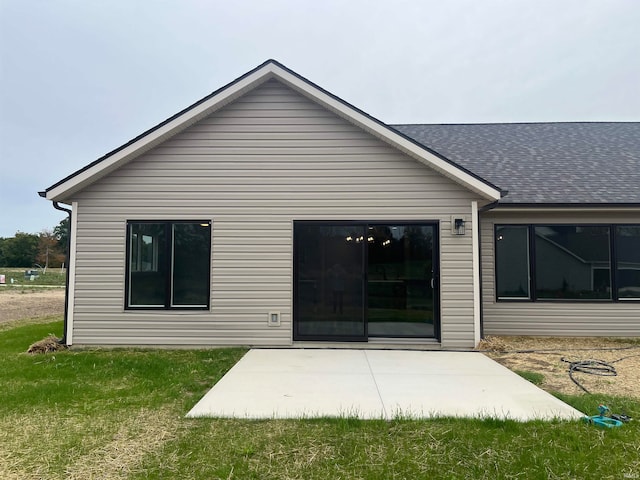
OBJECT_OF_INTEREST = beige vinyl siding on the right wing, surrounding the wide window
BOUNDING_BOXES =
[480,210,640,336]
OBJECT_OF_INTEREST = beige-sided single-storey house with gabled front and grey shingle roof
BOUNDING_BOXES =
[40,60,640,349]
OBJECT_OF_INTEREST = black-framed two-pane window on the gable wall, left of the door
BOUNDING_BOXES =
[126,221,211,309]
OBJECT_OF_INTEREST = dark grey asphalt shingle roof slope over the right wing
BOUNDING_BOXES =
[390,122,640,204]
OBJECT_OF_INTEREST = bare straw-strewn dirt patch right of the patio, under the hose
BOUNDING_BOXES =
[479,337,640,399]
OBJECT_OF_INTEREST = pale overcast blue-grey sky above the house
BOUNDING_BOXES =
[0,0,640,237]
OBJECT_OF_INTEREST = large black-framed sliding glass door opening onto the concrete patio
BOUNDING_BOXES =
[294,222,439,341]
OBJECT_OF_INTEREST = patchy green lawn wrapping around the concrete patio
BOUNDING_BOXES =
[0,317,640,479]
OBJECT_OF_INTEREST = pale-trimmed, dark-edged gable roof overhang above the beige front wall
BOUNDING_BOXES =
[43,60,502,201]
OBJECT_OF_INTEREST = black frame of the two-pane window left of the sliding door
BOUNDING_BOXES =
[124,219,213,311]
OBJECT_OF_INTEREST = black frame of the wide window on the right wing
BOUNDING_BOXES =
[493,222,640,303]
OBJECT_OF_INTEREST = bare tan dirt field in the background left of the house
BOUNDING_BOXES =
[0,287,64,323]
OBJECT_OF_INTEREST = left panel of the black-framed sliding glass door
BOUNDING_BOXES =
[294,224,366,341]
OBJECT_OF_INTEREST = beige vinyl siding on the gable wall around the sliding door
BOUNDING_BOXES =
[67,81,479,348]
